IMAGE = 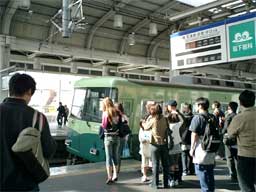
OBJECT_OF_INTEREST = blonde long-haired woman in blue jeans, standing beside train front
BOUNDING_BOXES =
[101,97,120,184]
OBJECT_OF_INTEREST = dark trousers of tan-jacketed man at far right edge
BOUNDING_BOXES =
[237,156,256,192]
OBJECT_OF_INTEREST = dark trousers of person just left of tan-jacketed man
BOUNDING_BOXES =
[225,145,237,179]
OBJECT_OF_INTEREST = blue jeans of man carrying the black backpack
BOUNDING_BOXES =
[195,164,215,192]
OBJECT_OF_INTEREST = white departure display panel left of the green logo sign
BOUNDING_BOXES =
[171,22,227,69]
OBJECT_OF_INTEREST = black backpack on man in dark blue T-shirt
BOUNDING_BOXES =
[201,114,221,152]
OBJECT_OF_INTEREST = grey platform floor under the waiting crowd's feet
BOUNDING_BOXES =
[40,160,240,192]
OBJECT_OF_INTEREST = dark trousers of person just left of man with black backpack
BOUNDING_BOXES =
[181,150,195,174]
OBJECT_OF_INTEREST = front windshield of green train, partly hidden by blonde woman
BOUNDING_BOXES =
[82,88,117,122]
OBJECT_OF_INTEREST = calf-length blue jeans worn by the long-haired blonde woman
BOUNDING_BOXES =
[104,135,120,166]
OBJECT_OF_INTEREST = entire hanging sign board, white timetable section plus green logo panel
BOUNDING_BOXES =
[170,13,256,70]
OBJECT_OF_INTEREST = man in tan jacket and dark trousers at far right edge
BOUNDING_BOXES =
[228,90,256,192]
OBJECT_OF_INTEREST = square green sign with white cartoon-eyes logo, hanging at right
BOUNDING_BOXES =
[229,21,256,59]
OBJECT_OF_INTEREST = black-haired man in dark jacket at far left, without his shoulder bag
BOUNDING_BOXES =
[0,73,56,191]
